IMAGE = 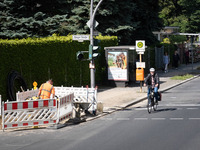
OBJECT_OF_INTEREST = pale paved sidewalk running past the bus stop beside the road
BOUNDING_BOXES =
[97,62,200,113]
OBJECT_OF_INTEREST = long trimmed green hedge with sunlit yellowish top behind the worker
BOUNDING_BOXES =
[0,35,118,100]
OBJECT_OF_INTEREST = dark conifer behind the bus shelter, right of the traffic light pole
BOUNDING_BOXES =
[96,0,162,45]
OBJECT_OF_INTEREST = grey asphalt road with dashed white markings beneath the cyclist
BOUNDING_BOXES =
[0,78,200,150]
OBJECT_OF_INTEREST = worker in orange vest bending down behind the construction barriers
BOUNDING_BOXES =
[38,79,55,99]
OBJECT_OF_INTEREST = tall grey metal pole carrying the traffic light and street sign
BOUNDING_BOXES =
[90,0,103,88]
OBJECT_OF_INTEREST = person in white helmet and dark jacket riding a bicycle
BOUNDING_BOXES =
[144,68,160,104]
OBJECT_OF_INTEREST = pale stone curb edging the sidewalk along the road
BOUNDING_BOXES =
[86,75,200,121]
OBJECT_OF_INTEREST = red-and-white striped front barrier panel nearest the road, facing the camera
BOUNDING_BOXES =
[2,99,57,130]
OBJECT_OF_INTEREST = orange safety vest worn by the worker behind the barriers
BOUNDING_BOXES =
[39,83,55,99]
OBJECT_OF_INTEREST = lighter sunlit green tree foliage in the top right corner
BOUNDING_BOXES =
[159,0,200,33]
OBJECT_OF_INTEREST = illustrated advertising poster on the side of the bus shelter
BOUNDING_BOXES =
[107,51,128,81]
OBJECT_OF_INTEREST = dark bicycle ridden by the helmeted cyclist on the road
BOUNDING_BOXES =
[147,87,158,114]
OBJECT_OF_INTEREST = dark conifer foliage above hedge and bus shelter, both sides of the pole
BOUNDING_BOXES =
[0,0,162,44]
